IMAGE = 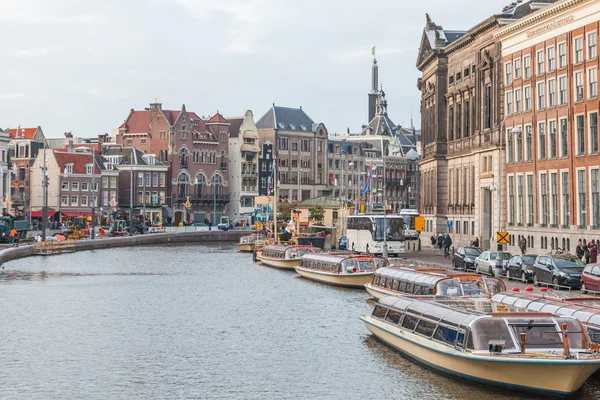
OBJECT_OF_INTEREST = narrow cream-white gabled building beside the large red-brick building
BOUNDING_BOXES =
[225,110,260,219]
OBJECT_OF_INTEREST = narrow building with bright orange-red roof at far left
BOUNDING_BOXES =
[8,126,45,214]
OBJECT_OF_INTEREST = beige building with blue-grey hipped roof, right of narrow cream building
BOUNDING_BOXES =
[256,105,329,201]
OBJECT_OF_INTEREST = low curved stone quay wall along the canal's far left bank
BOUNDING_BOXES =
[0,230,250,265]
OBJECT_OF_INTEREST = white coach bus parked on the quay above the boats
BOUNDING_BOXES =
[346,214,405,256]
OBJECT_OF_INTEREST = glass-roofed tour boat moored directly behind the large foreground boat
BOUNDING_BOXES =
[365,267,506,299]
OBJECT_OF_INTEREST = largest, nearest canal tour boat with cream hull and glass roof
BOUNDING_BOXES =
[361,296,600,395]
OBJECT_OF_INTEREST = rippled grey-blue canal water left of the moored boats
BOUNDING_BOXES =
[0,245,600,400]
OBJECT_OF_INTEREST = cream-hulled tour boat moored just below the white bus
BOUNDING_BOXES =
[296,253,389,289]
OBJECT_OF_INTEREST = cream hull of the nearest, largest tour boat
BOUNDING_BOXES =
[361,316,600,395]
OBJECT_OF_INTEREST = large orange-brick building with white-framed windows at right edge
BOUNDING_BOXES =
[495,0,600,252]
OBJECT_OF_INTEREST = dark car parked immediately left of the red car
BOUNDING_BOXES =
[532,254,584,289]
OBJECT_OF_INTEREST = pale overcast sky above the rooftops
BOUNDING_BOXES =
[0,0,509,137]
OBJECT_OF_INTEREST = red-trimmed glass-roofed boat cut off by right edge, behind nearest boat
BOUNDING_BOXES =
[492,291,600,345]
